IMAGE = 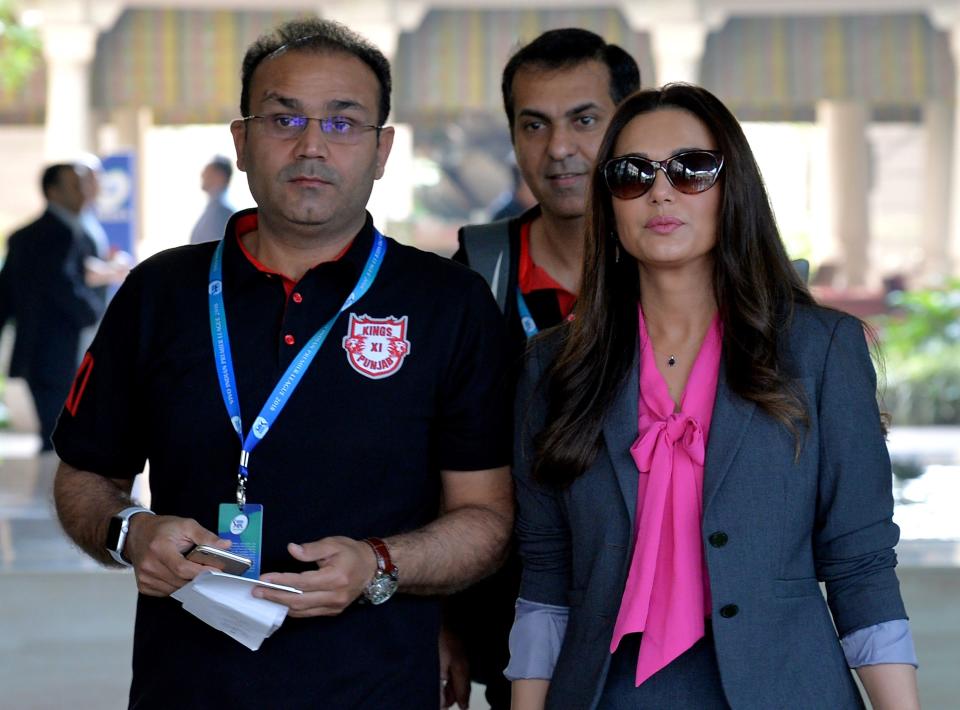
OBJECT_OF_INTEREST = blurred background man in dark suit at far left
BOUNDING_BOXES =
[0,163,103,451]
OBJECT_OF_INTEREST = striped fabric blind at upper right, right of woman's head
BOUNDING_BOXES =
[701,14,954,120]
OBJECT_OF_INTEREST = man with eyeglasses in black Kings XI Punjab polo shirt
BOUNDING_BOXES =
[54,21,512,710]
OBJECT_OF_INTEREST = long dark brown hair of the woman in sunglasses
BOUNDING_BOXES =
[534,84,814,486]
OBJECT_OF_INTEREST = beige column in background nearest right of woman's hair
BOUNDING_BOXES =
[812,101,870,287]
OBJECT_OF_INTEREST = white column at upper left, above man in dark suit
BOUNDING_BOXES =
[40,22,98,161]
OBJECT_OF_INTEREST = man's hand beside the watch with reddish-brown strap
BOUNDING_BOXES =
[253,537,377,617]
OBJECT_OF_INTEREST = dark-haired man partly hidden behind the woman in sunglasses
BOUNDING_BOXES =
[446,29,640,710]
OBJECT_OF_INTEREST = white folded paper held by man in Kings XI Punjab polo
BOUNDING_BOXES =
[172,570,287,651]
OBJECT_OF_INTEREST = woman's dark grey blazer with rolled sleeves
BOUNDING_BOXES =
[514,306,906,710]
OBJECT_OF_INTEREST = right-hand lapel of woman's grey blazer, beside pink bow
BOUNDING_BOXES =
[703,368,757,510]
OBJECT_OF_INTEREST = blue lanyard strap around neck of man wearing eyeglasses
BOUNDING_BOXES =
[207,229,387,508]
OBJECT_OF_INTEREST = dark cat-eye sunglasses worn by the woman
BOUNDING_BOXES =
[602,150,723,200]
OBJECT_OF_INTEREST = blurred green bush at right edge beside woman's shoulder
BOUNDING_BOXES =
[878,279,960,425]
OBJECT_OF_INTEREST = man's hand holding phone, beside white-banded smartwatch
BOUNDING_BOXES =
[124,514,230,597]
